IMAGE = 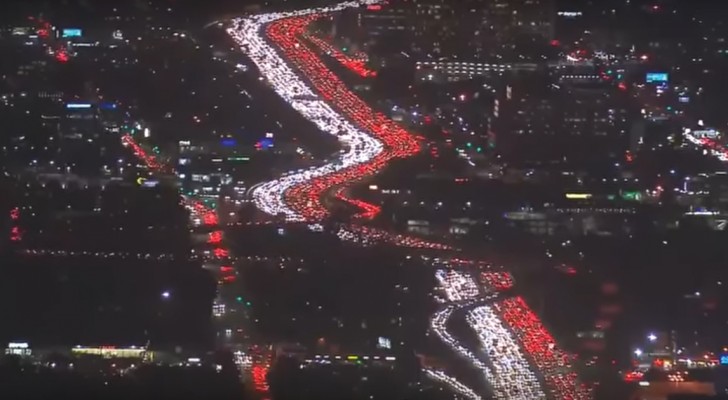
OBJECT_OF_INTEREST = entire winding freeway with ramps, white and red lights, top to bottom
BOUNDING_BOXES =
[227,1,591,400]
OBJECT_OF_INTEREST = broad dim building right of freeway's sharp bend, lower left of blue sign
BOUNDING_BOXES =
[492,79,636,162]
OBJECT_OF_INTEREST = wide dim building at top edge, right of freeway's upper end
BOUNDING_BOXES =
[352,0,553,61]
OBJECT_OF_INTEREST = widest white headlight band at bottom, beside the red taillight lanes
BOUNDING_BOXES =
[467,306,546,400]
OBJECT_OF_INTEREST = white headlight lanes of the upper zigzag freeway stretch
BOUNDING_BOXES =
[228,1,383,221]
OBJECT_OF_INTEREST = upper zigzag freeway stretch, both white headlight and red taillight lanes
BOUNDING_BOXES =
[228,2,419,221]
